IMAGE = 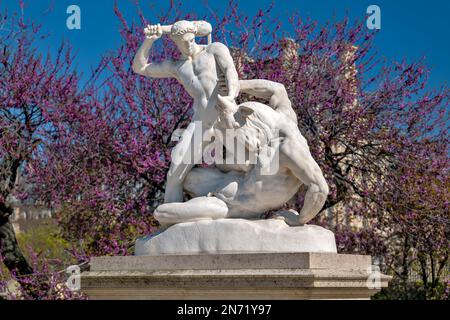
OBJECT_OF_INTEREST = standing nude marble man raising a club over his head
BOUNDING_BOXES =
[133,20,239,203]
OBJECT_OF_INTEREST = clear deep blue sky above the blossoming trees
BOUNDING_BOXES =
[0,0,450,87]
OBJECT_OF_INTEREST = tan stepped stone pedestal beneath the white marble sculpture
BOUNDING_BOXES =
[81,252,390,300]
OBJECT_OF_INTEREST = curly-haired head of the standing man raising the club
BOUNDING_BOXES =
[170,20,197,56]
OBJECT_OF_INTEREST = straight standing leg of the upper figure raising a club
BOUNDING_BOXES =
[164,122,202,203]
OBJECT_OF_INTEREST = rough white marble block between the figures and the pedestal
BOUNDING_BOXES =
[135,219,336,256]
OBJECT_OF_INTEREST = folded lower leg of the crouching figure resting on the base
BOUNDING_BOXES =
[153,197,228,225]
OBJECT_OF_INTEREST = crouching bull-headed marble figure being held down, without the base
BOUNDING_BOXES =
[154,79,328,226]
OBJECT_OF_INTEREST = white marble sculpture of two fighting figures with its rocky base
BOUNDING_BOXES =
[133,21,336,255]
